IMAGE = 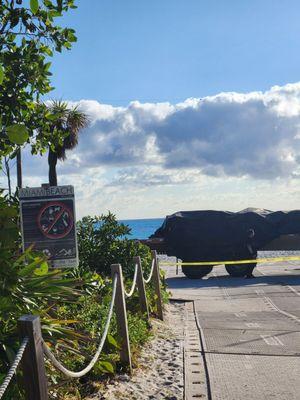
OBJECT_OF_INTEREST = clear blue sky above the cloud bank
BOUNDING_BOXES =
[51,0,300,105]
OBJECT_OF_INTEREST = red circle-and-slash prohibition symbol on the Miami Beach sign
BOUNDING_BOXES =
[37,201,74,239]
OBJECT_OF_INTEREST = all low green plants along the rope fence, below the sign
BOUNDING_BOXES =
[0,211,166,400]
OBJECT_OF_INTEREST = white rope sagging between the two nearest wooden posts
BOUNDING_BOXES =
[43,274,118,378]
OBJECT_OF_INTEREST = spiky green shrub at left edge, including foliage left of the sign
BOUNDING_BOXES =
[0,193,94,399]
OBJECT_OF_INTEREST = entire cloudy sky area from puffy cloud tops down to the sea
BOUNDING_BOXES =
[2,82,300,217]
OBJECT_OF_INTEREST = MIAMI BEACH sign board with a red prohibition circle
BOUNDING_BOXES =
[19,186,78,268]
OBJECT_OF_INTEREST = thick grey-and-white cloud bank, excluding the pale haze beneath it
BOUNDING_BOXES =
[65,83,300,179]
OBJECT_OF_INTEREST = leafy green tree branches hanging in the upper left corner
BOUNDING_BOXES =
[0,0,76,159]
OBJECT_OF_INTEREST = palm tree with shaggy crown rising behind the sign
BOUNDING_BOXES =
[48,100,89,186]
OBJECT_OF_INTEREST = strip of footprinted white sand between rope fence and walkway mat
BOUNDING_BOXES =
[90,303,184,400]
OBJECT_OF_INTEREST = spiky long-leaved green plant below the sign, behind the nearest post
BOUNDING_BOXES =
[0,250,80,398]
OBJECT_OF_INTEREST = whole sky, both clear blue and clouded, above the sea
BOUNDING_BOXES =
[2,0,300,219]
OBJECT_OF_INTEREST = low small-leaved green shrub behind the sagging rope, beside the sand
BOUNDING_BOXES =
[49,288,151,400]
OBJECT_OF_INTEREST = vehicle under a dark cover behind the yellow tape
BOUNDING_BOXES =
[143,209,300,278]
